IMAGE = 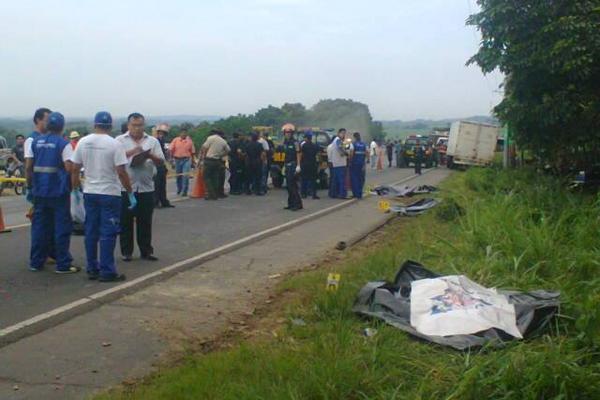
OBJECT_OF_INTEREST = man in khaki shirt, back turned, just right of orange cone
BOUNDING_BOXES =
[200,129,231,200]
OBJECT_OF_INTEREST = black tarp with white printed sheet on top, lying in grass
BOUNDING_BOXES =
[353,261,560,350]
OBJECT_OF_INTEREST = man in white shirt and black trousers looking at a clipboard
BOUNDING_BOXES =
[117,113,165,262]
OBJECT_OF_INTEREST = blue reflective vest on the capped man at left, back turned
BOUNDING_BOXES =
[31,133,69,197]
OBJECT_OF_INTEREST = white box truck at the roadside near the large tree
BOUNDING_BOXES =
[446,121,500,168]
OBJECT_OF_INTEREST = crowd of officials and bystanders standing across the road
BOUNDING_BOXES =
[18,108,369,282]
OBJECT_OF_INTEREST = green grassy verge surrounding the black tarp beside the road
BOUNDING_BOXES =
[99,169,600,399]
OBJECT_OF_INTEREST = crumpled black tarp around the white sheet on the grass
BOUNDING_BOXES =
[353,261,560,350]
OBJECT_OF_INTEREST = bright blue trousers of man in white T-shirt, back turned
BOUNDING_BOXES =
[83,194,121,278]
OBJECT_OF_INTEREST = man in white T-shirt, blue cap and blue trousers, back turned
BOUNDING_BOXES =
[71,111,137,282]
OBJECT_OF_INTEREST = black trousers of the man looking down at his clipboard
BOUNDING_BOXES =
[119,192,154,256]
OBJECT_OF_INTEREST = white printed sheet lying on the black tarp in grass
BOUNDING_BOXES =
[410,275,523,339]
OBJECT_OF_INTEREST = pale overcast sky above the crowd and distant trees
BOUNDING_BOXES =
[0,0,502,120]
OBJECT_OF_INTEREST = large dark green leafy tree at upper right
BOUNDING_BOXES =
[467,0,600,170]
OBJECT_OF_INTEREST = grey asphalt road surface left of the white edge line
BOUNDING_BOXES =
[0,169,422,328]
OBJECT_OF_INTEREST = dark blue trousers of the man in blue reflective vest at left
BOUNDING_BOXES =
[29,194,73,271]
